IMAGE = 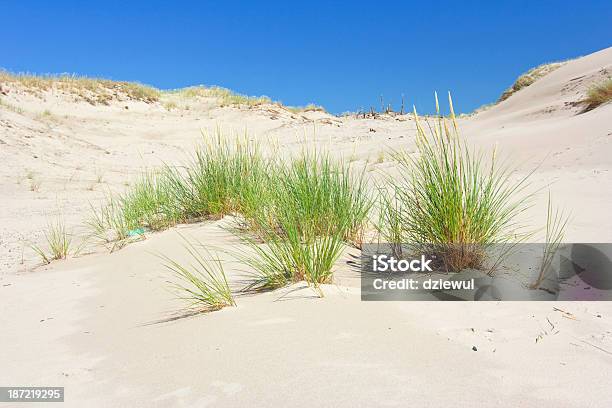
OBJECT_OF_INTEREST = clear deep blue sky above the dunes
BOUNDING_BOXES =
[0,0,612,113]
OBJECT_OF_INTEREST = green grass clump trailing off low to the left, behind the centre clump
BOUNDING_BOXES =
[87,133,270,249]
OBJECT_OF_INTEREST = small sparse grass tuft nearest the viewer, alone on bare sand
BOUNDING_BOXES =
[159,236,236,311]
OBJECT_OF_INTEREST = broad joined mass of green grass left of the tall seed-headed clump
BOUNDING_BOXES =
[88,134,371,296]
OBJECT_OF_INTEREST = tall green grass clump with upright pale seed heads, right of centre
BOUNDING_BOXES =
[381,94,532,271]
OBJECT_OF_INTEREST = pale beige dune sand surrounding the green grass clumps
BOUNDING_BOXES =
[0,48,612,407]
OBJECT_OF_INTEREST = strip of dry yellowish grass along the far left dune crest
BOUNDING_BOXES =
[0,71,160,105]
